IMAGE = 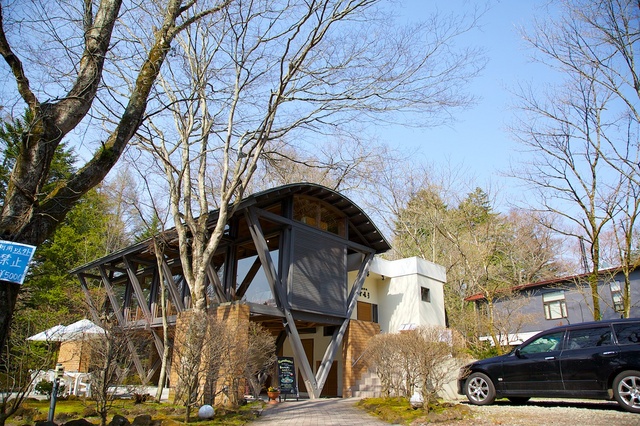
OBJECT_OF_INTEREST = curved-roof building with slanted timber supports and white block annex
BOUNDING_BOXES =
[72,183,445,398]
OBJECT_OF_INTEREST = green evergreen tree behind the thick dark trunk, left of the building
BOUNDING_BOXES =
[0,110,128,332]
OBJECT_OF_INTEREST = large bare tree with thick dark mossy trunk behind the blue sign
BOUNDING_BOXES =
[0,0,230,347]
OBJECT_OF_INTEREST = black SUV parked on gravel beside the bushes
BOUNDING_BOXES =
[458,318,640,413]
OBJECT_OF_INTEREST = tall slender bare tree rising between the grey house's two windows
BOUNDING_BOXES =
[514,0,640,319]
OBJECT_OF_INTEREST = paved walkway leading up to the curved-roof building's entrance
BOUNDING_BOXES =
[251,398,389,426]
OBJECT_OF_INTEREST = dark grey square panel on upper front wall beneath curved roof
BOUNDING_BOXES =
[289,229,347,317]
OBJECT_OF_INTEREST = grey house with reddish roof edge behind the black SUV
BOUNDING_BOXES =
[465,268,640,344]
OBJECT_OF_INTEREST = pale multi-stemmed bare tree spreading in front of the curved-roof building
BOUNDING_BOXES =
[137,0,481,320]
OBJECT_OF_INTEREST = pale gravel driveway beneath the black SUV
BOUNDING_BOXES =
[440,399,640,426]
